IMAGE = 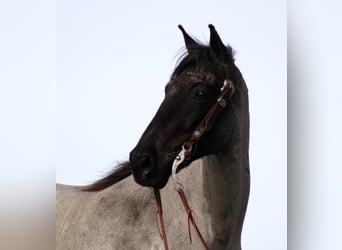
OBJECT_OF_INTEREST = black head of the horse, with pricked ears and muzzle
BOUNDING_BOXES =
[130,25,240,188]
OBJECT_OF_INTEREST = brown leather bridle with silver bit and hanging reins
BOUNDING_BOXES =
[154,79,235,250]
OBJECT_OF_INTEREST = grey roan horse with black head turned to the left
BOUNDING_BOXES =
[56,24,250,250]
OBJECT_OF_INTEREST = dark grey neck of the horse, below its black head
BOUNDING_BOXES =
[202,77,250,250]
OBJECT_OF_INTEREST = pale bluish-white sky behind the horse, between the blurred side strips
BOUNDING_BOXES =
[56,1,287,250]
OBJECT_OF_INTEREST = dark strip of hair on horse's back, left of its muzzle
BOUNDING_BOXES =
[82,162,131,192]
